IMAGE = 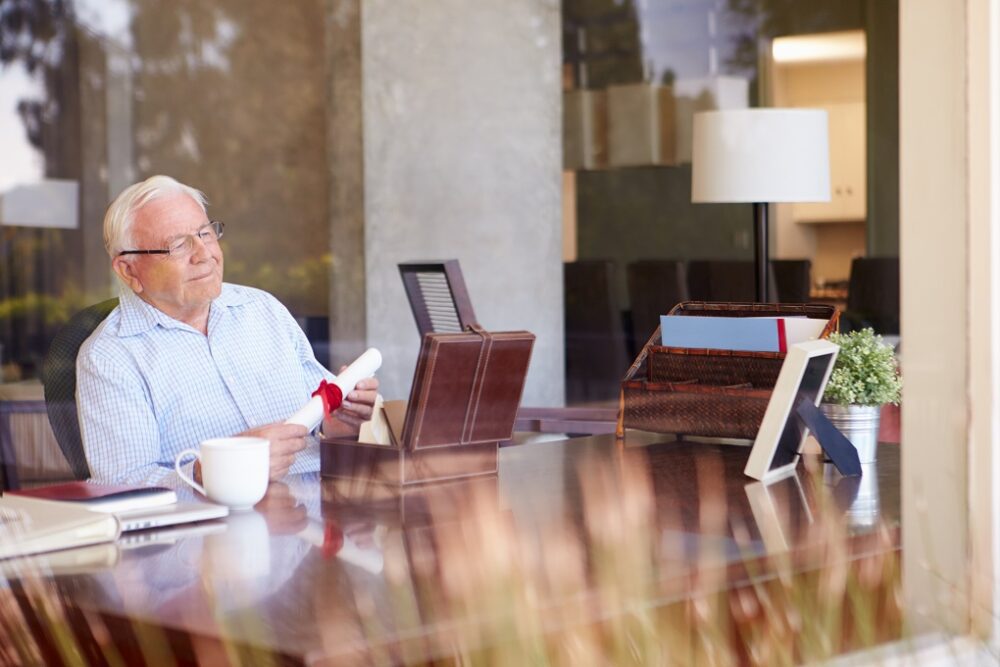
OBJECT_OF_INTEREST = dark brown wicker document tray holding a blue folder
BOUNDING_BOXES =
[618,301,839,438]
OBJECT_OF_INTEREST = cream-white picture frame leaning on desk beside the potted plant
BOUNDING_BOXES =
[743,340,840,482]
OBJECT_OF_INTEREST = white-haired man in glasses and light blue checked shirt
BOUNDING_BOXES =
[77,176,378,485]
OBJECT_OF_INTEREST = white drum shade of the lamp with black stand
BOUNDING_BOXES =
[691,109,830,203]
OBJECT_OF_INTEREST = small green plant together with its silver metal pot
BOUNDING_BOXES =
[820,328,902,463]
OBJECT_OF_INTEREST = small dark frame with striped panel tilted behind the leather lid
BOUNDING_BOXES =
[399,259,478,338]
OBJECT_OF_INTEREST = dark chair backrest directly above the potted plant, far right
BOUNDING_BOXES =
[844,257,899,335]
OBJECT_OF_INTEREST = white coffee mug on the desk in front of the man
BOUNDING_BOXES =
[174,436,271,510]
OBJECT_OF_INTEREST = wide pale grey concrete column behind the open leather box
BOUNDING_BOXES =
[360,0,564,405]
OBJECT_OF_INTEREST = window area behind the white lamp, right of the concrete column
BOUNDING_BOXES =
[563,0,899,403]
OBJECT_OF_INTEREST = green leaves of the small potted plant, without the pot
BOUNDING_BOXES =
[823,328,902,406]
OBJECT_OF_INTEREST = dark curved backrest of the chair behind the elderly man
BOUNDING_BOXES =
[42,298,118,479]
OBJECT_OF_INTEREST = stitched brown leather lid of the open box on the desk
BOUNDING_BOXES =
[402,331,535,449]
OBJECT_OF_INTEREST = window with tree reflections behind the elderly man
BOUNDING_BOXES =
[0,0,331,381]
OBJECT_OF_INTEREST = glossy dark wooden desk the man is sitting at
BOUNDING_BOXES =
[0,433,901,664]
